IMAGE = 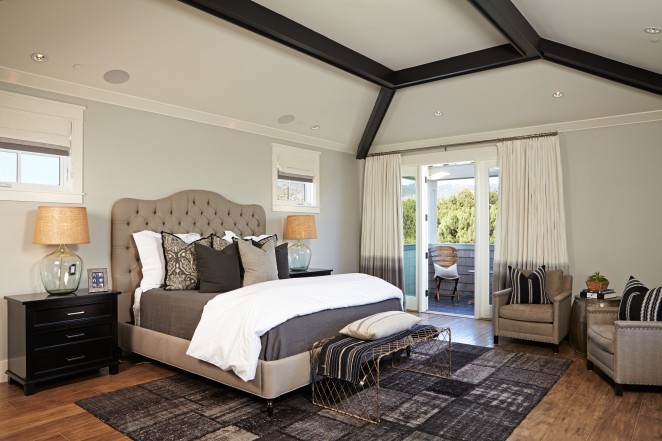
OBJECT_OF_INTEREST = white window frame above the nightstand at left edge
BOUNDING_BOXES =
[0,90,85,204]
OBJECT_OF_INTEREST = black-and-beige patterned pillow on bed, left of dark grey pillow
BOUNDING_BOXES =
[161,231,211,291]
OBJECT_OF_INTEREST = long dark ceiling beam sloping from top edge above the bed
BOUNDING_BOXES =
[179,0,393,88]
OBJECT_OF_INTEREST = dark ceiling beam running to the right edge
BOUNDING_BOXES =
[540,39,662,95]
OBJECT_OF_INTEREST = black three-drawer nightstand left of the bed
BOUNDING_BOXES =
[5,290,119,395]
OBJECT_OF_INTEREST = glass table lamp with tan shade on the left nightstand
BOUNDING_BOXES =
[32,207,90,294]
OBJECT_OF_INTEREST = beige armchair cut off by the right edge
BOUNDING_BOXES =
[586,307,662,395]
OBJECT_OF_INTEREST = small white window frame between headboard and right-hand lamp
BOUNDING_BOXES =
[271,143,320,213]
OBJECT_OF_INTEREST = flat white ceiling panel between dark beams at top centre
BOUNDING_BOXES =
[255,0,507,70]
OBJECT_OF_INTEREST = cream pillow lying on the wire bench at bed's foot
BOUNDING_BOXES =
[340,311,421,340]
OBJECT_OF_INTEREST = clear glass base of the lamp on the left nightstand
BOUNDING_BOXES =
[39,245,83,294]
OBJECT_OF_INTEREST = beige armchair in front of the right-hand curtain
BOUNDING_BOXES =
[492,270,572,354]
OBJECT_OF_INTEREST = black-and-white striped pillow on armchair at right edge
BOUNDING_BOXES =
[618,276,662,321]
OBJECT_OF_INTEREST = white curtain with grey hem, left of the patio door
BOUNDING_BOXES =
[359,154,404,289]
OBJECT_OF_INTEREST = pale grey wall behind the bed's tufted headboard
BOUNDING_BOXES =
[0,83,360,380]
